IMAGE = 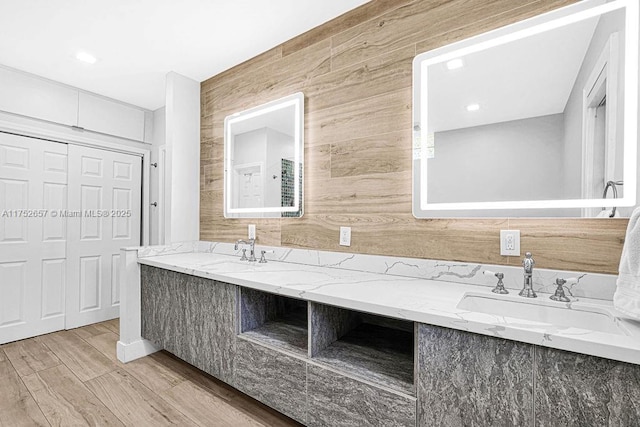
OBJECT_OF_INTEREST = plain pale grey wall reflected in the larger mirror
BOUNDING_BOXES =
[427,114,563,203]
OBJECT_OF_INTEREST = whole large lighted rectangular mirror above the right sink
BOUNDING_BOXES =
[413,0,639,218]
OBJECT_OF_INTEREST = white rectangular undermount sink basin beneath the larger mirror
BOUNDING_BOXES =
[457,293,628,335]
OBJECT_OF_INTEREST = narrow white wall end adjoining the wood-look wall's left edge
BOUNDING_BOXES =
[164,72,200,243]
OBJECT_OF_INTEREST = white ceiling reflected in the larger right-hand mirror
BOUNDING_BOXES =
[427,17,599,132]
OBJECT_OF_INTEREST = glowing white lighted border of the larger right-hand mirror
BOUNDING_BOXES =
[412,0,639,218]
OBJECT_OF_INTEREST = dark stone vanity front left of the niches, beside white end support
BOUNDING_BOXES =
[140,265,236,385]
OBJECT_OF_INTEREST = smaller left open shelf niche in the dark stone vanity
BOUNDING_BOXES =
[240,287,309,357]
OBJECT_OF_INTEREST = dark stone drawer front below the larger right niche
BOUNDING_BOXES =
[307,364,416,427]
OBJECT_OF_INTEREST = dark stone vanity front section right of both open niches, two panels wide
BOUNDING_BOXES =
[417,324,640,426]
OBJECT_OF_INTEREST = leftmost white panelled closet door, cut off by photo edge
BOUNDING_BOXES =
[0,133,67,344]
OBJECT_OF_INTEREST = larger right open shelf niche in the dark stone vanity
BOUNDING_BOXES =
[309,303,415,395]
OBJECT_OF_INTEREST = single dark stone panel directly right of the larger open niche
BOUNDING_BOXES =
[417,324,533,426]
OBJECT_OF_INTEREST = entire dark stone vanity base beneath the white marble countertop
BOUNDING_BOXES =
[140,265,640,427]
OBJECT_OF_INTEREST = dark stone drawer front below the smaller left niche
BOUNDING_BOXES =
[235,338,307,423]
